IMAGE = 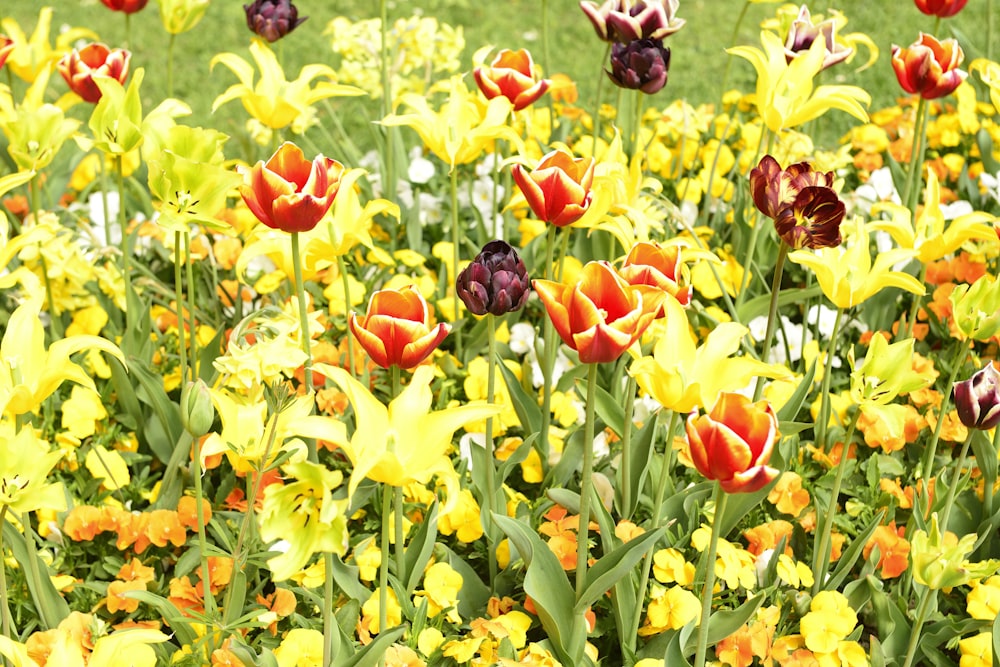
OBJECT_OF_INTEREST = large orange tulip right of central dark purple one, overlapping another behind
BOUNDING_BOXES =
[532,262,665,364]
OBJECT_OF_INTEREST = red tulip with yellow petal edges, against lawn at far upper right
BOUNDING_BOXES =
[892,33,968,100]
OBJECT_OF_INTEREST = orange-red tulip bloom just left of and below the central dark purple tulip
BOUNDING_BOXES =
[347,285,451,368]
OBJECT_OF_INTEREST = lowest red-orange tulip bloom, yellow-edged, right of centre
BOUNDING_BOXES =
[687,393,778,493]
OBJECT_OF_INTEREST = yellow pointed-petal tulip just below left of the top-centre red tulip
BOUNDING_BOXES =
[382,76,523,169]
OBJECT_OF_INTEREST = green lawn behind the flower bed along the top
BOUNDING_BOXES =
[0,0,986,145]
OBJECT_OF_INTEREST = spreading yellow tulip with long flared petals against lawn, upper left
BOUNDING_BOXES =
[209,39,364,130]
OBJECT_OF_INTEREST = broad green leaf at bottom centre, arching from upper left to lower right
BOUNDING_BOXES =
[493,513,587,665]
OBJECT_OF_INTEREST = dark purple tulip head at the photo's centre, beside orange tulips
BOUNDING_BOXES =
[455,241,531,315]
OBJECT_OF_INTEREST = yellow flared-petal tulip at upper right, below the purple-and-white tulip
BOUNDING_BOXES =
[726,31,871,134]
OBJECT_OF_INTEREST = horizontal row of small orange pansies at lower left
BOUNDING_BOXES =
[62,496,212,554]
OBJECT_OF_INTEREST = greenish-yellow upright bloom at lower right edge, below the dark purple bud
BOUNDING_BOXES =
[910,512,1000,590]
